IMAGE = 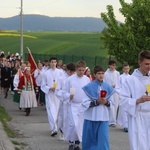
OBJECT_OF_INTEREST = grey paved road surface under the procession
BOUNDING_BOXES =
[0,93,129,150]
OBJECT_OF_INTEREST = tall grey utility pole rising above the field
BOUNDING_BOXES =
[20,0,23,59]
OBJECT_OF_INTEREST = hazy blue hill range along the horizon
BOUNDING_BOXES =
[0,15,106,32]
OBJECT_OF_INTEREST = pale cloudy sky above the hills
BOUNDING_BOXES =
[0,0,132,21]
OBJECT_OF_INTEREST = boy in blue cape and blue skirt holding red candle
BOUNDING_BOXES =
[82,66,114,150]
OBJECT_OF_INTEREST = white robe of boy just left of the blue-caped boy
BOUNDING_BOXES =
[64,74,90,142]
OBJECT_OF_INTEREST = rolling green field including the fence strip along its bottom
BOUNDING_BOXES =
[0,31,111,68]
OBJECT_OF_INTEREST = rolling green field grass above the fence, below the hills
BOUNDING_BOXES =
[0,31,107,57]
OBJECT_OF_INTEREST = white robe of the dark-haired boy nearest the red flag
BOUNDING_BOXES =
[41,68,62,131]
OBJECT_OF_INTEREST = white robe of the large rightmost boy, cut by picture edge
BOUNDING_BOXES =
[120,69,150,150]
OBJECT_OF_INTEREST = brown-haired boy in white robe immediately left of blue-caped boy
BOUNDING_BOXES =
[64,61,90,150]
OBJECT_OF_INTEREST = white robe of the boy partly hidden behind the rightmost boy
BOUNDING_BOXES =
[115,73,130,128]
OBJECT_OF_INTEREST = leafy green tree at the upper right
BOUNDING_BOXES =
[101,0,150,66]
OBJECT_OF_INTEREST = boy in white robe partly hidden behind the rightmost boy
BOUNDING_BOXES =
[115,64,130,132]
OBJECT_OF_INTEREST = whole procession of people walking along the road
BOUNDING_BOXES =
[0,50,150,150]
